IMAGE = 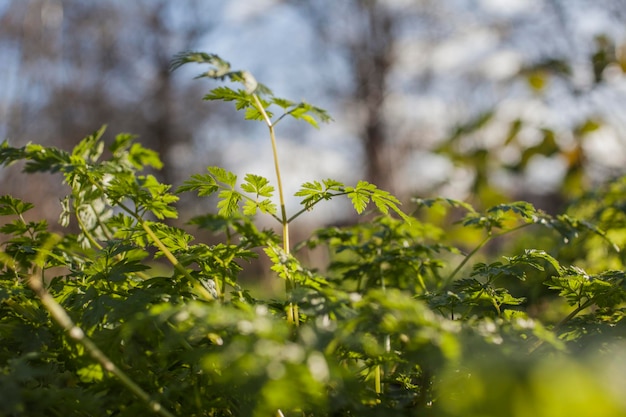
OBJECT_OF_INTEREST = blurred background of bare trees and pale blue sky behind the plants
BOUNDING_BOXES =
[0,0,626,228]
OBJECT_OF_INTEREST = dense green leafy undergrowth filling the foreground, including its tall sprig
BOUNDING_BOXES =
[0,53,626,417]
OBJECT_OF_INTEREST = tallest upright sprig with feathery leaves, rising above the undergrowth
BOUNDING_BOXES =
[172,52,406,325]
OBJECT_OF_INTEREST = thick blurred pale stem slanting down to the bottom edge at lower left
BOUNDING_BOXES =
[28,275,174,417]
